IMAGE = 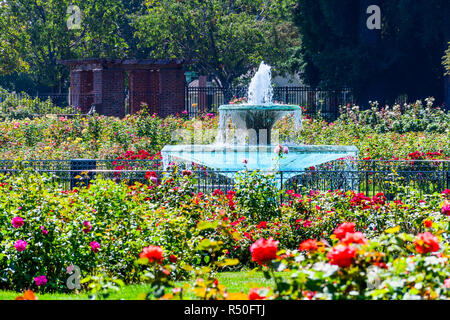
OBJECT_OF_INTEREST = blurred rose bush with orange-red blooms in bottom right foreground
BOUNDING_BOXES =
[260,222,450,300]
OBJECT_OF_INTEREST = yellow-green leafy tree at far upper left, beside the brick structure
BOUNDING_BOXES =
[0,0,127,92]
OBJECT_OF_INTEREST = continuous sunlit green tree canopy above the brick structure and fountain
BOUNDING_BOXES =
[0,0,299,92]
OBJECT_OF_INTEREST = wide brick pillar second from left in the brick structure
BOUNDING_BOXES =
[93,69,125,118]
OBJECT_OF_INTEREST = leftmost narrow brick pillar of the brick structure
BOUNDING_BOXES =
[70,70,94,113]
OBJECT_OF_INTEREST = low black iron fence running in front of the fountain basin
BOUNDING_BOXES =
[0,159,450,198]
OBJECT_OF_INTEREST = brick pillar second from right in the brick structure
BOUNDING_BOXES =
[129,70,159,114]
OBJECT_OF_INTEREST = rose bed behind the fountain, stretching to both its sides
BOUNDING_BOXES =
[0,97,450,160]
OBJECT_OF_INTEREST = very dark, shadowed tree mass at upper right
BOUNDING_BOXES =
[294,0,448,104]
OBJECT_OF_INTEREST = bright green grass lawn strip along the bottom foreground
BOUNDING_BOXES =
[0,271,282,300]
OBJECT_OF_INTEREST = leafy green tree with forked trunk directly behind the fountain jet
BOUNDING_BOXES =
[135,0,299,99]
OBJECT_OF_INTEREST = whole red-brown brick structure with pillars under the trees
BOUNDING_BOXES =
[65,60,186,118]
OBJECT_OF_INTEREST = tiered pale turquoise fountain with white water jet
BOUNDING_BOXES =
[161,62,358,178]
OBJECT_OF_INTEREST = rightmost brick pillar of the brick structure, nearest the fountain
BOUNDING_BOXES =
[158,68,186,117]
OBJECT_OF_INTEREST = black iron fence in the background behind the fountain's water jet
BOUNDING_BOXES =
[186,87,353,120]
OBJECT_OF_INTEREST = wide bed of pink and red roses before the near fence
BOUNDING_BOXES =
[0,167,450,291]
